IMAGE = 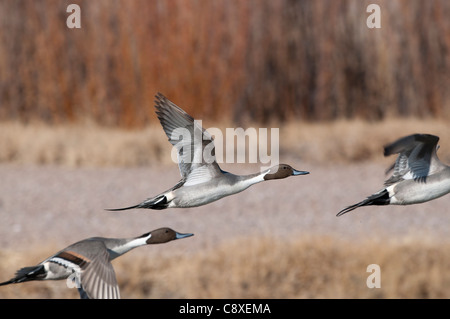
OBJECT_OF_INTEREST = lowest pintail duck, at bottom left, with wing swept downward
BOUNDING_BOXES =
[0,228,193,299]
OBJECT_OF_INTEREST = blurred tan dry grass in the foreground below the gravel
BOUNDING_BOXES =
[0,236,450,299]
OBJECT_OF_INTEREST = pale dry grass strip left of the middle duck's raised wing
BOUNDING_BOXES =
[0,122,170,167]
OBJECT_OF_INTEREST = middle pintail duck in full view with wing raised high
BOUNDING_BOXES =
[107,93,309,211]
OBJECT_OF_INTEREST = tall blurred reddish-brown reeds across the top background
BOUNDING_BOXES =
[0,0,450,127]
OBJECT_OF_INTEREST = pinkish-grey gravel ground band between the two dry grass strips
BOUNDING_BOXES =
[0,163,450,258]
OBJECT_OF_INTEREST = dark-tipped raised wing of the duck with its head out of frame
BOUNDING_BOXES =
[384,134,443,186]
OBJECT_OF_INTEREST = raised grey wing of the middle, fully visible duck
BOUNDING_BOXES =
[155,93,220,184]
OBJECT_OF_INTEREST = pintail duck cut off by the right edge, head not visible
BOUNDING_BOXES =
[337,134,450,216]
